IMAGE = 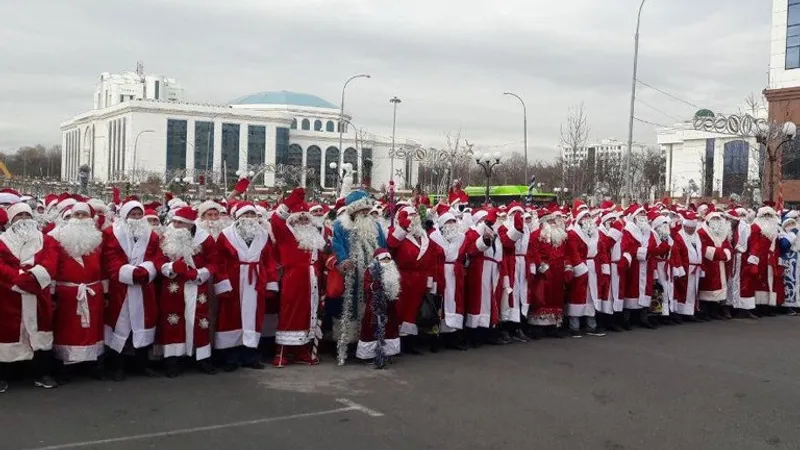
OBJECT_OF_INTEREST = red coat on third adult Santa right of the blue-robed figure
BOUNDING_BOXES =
[462,223,508,328]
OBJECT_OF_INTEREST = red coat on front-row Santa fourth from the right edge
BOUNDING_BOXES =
[697,227,732,303]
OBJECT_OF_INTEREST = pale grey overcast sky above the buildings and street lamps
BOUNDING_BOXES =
[0,0,771,159]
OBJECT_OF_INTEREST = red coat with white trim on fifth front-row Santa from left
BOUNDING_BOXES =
[214,225,278,349]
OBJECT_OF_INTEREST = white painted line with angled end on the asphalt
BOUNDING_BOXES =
[22,398,383,450]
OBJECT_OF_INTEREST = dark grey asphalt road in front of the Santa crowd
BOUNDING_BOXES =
[0,317,800,450]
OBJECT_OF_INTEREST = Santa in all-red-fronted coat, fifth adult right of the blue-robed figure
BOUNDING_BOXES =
[528,205,573,337]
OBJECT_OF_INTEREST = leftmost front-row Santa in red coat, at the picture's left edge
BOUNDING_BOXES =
[0,203,57,392]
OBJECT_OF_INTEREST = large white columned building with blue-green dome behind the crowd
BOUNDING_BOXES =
[61,72,418,190]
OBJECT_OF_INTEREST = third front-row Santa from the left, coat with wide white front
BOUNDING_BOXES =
[103,200,164,381]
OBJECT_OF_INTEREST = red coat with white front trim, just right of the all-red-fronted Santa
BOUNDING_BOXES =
[566,229,611,317]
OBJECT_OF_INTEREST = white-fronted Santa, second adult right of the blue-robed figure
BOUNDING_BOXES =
[430,205,467,350]
